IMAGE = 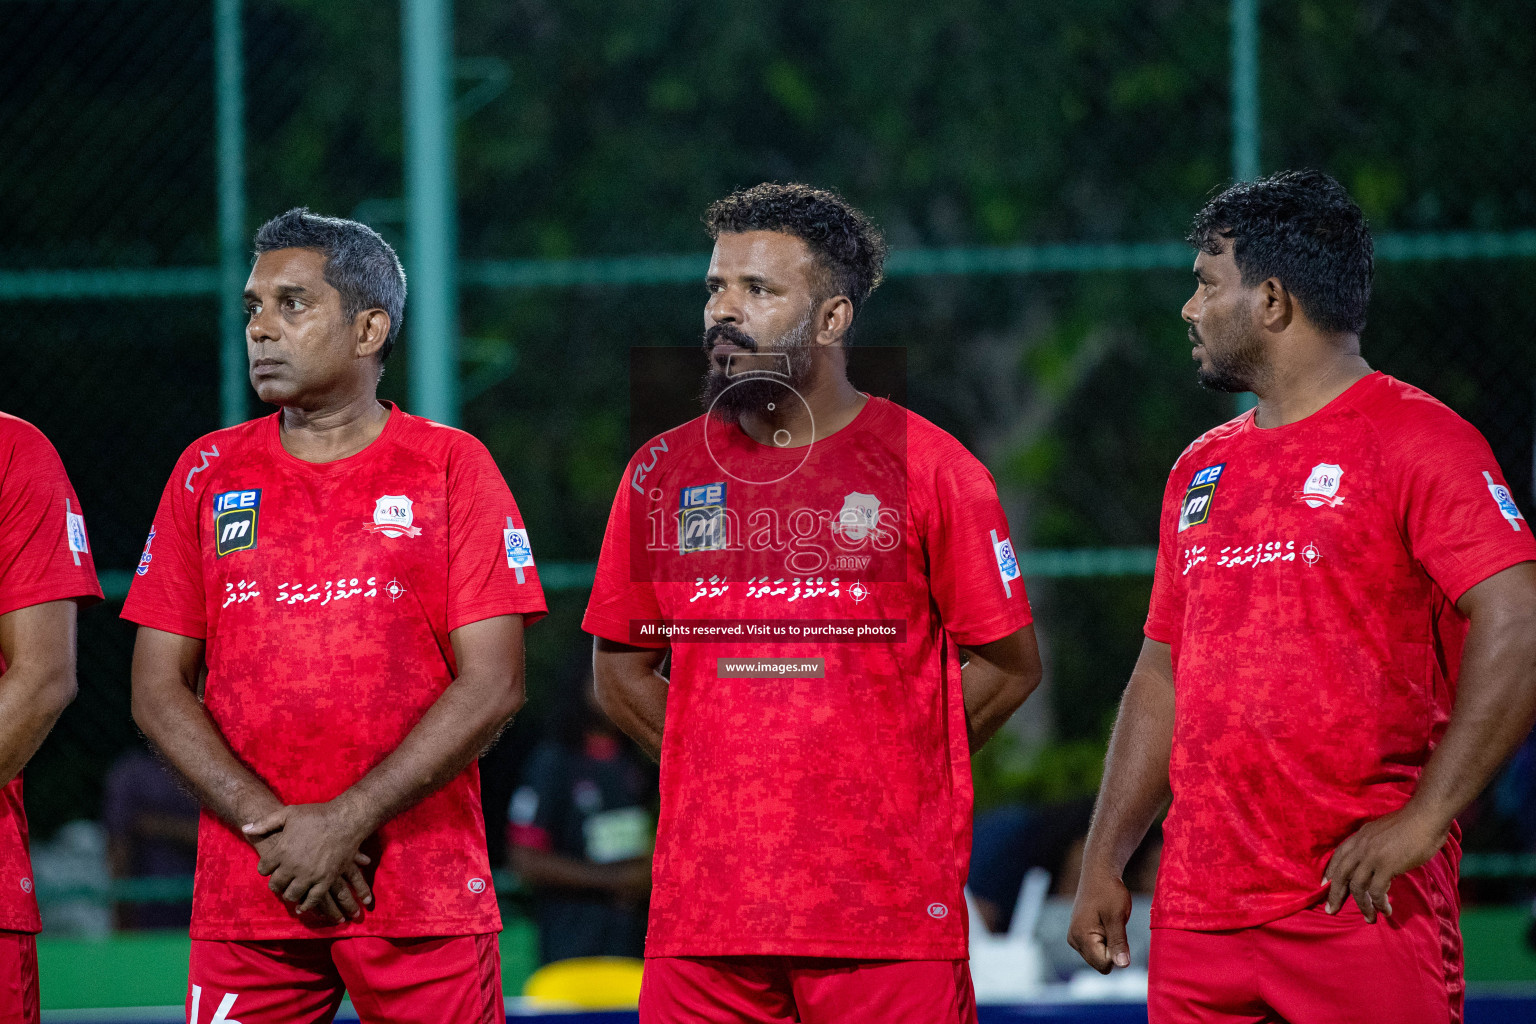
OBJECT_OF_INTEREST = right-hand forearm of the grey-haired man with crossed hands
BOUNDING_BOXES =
[333,669,524,840]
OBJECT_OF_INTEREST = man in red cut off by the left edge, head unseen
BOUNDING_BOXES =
[0,413,101,1024]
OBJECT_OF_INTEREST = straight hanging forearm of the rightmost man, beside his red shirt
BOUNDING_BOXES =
[1083,647,1174,878]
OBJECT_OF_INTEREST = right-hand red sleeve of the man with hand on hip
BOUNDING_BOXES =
[1384,407,1536,602]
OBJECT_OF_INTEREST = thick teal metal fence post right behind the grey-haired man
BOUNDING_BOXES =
[401,0,459,425]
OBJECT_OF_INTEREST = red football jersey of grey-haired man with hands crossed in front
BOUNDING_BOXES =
[123,407,544,941]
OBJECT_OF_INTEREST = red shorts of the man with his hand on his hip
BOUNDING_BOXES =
[1147,855,1465,1024]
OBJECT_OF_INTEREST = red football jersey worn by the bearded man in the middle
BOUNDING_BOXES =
[584,399,1031,960]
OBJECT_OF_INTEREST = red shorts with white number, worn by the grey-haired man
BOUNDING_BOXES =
[187,935,507,1024]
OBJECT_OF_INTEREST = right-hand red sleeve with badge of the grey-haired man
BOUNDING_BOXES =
[449,436,547,631]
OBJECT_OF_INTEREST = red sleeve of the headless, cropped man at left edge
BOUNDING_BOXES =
[0,419,101,616]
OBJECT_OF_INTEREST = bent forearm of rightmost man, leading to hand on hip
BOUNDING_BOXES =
[1407,620,1536,831]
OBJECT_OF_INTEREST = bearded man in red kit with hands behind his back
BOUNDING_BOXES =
[582,184,1040,1024]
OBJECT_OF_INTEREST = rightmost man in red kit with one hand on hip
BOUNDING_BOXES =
[1071,170,1536,1024]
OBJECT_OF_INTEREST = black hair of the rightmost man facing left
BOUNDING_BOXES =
[1187,170,1375,335]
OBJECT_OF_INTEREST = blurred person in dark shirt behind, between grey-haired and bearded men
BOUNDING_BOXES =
[507,672,657,964]
